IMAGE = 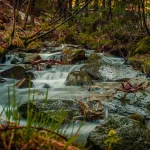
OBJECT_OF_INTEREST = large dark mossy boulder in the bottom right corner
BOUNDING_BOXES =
[86,115,150,150]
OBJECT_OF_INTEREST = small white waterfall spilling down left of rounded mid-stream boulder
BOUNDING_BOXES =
[33,65,83,88]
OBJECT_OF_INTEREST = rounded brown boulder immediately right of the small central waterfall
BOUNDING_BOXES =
[65,71,92,86]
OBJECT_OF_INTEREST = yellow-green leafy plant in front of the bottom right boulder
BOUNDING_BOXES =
[104,130,120,150]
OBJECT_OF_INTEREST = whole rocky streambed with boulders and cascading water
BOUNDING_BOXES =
[0,45,150,150]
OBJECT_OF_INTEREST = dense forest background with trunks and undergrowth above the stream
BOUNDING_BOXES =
[0,0,150,58]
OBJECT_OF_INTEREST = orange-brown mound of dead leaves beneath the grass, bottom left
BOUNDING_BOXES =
[0,120,79,150]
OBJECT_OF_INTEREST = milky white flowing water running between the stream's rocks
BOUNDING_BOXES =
[0,45,148,143]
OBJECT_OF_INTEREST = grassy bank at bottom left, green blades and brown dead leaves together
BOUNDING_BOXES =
[0,82,80,150]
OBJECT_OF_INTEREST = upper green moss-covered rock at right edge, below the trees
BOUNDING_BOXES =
[134,36,150,54]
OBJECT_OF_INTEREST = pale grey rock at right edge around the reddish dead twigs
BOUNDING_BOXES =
[108,77,150,119]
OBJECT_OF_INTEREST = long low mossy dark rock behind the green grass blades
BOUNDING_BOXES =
[18,99,80,123]
